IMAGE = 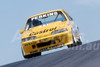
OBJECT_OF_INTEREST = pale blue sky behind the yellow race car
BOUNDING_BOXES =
[0,0,100,66]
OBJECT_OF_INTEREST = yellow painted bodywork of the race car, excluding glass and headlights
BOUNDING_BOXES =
[20,10,76,55]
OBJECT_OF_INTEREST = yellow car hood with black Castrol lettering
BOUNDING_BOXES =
[22,21,67,38]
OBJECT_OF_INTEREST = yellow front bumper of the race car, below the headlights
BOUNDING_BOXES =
[22,32,73,55]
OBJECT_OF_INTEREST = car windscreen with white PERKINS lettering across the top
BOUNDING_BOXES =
[26,11,66,30]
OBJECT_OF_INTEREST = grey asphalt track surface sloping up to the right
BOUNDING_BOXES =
[1,41,100,67]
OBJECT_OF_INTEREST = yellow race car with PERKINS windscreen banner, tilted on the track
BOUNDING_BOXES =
[20,9,82,58]
